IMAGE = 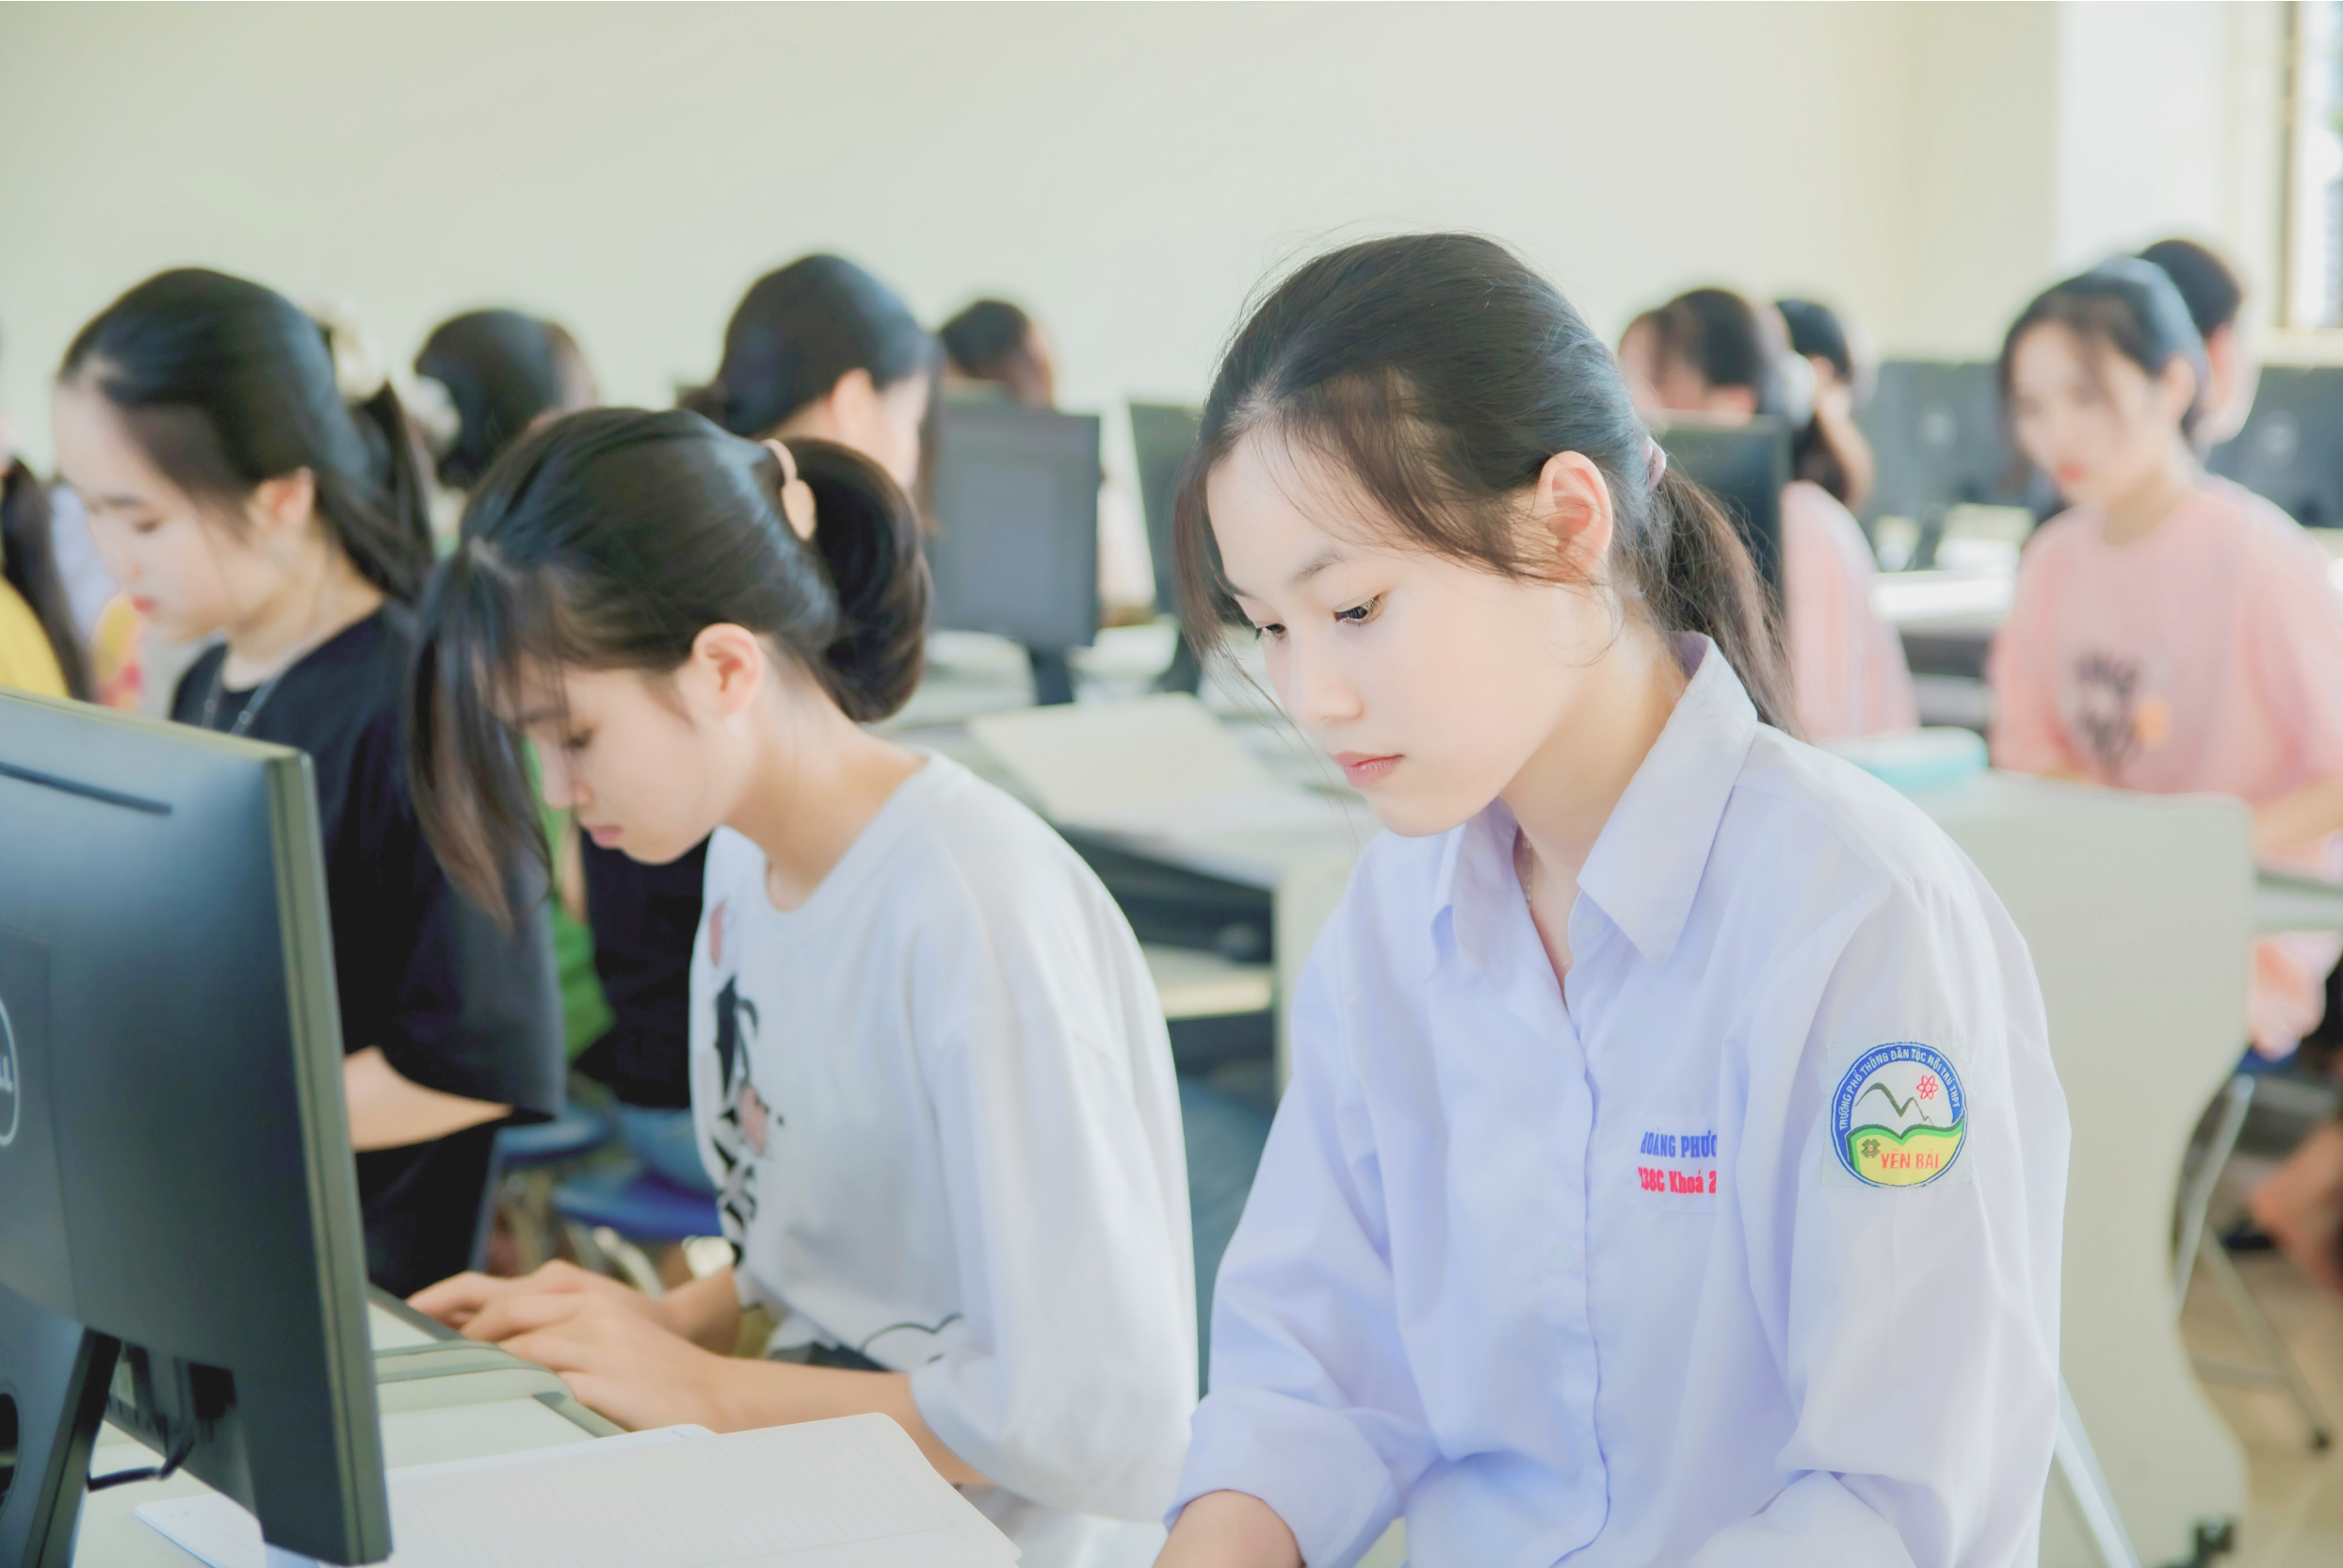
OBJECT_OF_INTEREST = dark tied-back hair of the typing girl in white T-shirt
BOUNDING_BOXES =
[408,408,928,910]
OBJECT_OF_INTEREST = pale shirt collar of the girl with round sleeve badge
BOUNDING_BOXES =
[1431,635,1757,968]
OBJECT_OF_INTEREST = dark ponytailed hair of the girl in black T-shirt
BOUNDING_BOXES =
[58,267,431,603]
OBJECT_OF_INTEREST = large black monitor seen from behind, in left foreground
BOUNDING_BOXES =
[0,691,391,1568]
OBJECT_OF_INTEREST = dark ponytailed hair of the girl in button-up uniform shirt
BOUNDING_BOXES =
[1173,234,1790,727]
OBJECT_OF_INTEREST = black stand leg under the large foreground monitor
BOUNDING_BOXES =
[0,1285,121,1568]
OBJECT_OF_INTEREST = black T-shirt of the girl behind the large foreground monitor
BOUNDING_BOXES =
[171,605,562,1296]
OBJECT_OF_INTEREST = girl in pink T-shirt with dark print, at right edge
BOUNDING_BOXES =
[1989,258,2343,1286]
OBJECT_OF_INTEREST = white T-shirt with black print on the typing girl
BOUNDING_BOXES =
[691,757,1195,1568]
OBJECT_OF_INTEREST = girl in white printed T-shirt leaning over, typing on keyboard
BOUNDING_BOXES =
[412,411,1195,1566]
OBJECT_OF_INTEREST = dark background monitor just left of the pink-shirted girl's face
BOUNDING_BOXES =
[1855,359,2044,539]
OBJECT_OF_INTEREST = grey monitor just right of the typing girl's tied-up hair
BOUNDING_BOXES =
[928,401,1101,652]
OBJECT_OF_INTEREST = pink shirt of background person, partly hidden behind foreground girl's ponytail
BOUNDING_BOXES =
[1781,478,1919,743]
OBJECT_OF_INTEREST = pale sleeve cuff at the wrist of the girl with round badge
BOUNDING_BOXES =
[1167,1387,1398,1563]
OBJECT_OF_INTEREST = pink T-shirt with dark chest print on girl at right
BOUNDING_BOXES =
[1987,480,2343,1057]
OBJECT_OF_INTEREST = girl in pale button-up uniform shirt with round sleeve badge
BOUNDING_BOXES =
[1160,234,2066,1568]
